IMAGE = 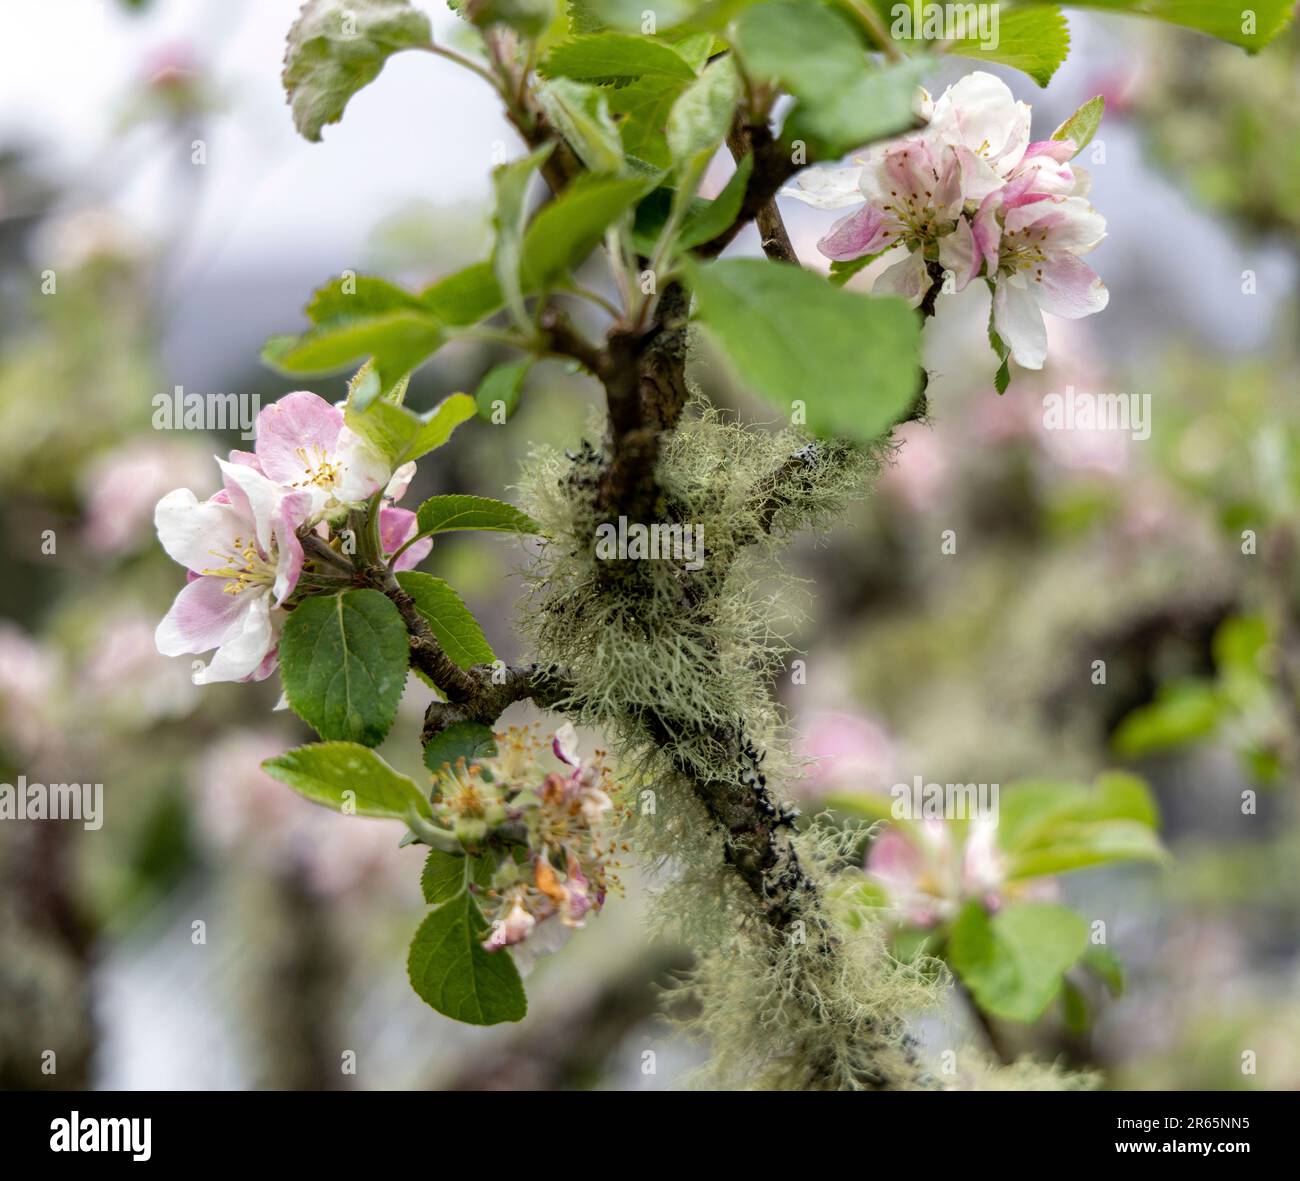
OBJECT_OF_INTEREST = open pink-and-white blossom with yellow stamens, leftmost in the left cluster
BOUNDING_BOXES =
[153,459,312,684]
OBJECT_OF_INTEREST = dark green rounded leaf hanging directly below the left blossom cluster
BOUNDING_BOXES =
[280,588,410,747]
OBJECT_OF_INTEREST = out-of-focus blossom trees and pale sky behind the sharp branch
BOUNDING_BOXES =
[0,3,1300,1089]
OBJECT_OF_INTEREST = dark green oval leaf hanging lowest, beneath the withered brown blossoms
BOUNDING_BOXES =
[407,892,528,1025]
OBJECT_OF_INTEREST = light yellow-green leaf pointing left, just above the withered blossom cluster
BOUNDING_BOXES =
[261,743,433,821]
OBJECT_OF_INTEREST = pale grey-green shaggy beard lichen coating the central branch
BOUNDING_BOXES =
[520,403,1081,1090]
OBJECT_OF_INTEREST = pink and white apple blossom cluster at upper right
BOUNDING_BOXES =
[785,72,1108,369]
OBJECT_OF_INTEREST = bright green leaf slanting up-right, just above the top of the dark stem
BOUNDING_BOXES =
[523,176,653,290]
